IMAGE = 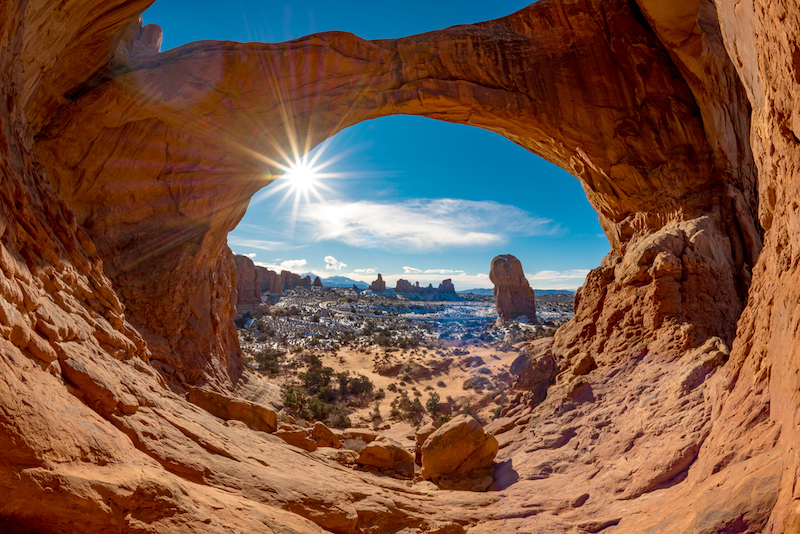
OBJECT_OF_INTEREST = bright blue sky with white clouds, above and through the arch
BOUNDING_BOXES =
[144,0,609,290]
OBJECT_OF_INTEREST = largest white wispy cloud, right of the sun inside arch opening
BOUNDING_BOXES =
[298,198,559,252]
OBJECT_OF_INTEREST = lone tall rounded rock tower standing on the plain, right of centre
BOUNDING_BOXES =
[489,254,538,324]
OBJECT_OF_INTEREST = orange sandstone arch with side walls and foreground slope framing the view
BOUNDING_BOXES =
[0,0,800,533]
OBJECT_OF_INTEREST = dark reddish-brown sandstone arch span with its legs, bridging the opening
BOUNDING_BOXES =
[36,1,760,390]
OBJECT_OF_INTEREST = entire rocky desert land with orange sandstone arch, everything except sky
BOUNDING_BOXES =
[0,0,800,534]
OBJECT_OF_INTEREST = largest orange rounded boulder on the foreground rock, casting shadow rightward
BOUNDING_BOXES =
[422,415,498,479]
